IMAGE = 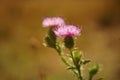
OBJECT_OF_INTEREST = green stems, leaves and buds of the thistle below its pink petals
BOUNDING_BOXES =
[45,18,103,80]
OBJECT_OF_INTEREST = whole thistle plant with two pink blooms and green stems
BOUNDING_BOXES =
[42,17,102,80]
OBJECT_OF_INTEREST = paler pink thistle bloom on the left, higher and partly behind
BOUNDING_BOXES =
[42,17,65,27]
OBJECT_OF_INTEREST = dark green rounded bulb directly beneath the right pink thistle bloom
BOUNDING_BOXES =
[64,37,74,49]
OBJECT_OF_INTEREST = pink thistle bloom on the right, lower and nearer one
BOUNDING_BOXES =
[54,25,81,37]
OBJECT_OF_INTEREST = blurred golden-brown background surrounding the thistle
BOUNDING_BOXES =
[0,0,120,80]
